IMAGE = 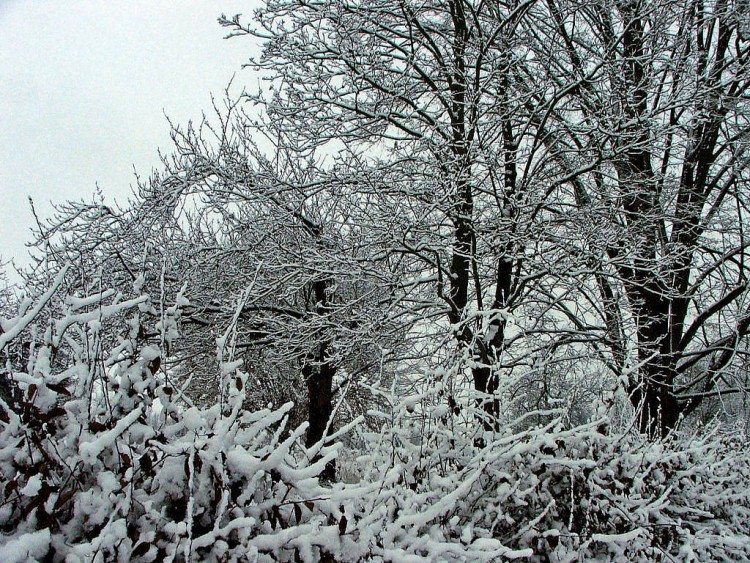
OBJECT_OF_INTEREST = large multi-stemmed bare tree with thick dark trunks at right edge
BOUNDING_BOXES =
[540,0,750,435]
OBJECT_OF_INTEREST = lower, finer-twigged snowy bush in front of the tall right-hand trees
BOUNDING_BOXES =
[349,376,750,561]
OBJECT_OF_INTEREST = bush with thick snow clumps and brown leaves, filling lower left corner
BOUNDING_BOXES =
[0,272,346,562]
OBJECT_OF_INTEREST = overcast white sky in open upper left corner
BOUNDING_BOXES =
[0,0,258,274]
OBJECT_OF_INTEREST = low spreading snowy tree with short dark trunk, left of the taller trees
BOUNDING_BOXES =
[32,106,403,478]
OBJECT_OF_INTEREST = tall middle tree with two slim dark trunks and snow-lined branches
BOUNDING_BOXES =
[223,0,612,429]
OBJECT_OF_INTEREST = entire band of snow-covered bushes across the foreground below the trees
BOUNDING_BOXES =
[0,272,750,561]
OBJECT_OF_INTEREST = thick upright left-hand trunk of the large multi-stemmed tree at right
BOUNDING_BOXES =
[618,4,679,438]
